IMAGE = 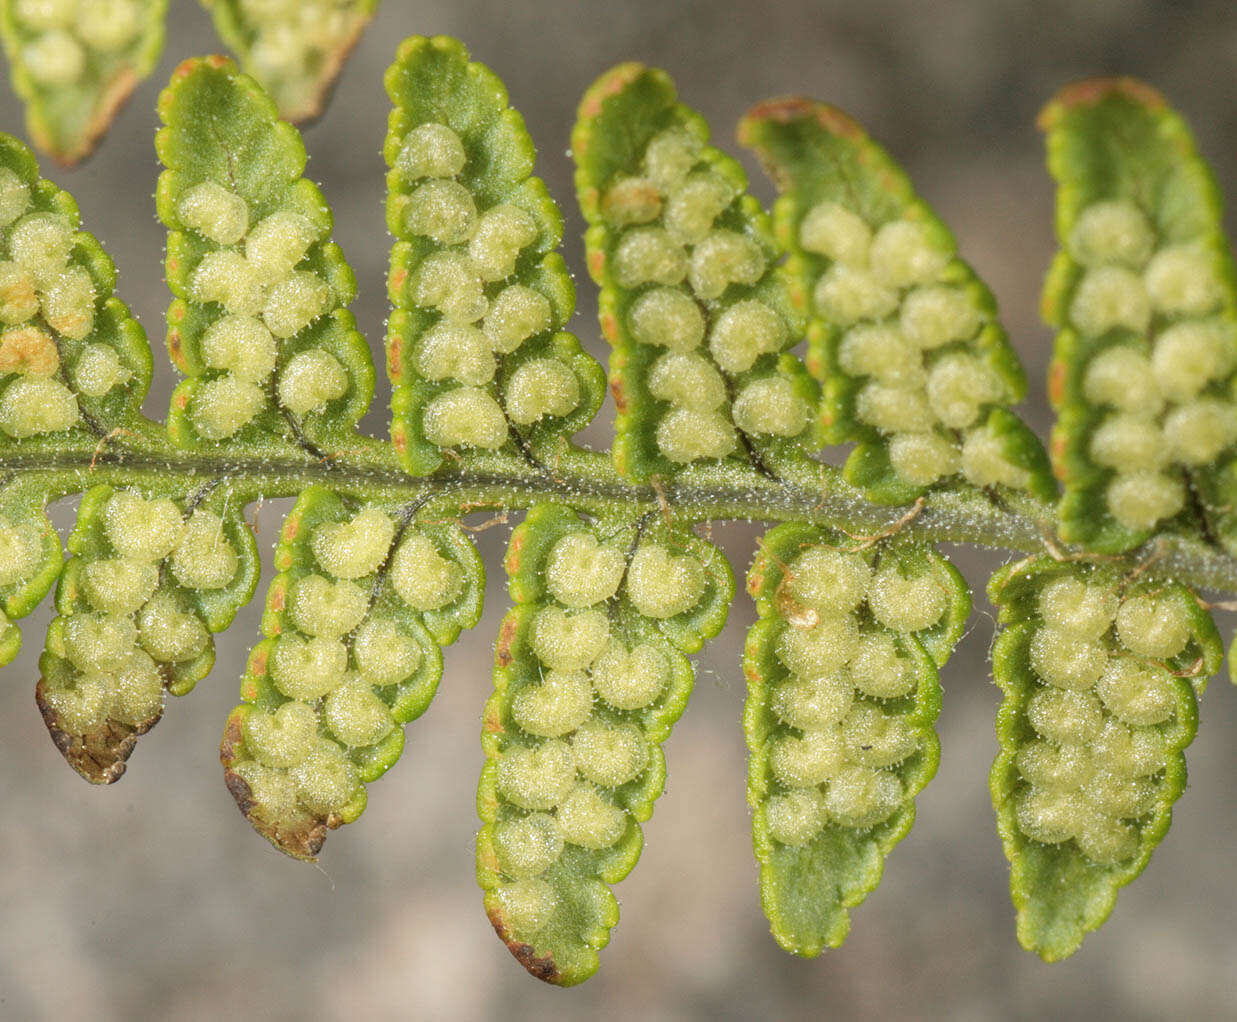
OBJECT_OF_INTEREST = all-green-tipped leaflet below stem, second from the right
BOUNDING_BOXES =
[745,525,970,955]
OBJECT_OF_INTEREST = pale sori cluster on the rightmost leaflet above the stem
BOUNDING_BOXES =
[1068,198,1237,532]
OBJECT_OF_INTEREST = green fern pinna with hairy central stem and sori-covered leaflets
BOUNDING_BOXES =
[0,35,1237,985]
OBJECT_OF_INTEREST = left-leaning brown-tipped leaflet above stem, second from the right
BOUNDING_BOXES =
[738,99,1055,504]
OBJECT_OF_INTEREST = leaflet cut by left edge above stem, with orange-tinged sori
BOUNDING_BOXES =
[0,136,150,439]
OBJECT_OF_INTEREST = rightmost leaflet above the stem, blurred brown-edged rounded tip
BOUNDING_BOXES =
[1040,78,1237,552]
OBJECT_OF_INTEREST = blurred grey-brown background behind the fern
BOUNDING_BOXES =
[0,0,1237,1022]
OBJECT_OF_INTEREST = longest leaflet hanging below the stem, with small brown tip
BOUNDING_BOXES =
[477,505,734,984]
